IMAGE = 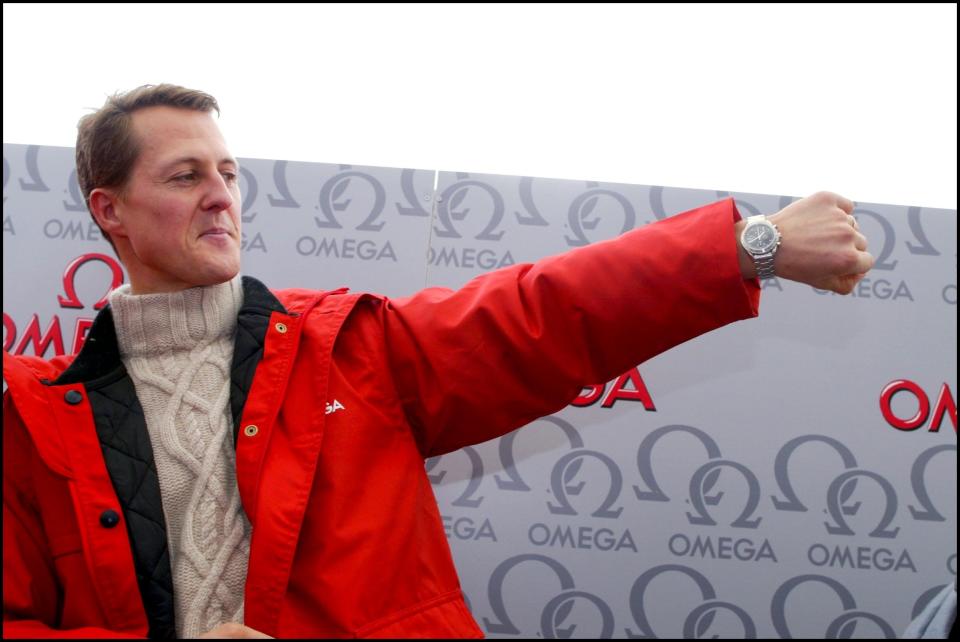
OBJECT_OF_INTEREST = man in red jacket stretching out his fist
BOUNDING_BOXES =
[3,85,873,637]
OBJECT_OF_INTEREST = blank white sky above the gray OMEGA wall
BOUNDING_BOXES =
[3,3,957,209]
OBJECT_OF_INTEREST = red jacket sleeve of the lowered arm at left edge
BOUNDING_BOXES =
[3,392,143,638]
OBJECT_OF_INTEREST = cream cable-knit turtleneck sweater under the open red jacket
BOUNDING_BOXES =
[110,275,250,638]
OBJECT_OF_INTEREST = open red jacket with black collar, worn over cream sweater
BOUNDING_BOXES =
[3,199,759,637]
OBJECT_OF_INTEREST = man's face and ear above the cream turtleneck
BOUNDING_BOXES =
[101,107,240,294]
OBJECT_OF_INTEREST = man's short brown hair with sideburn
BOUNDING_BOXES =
[76,84,220,251]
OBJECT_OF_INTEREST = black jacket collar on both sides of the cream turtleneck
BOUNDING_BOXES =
[52,276,288,385]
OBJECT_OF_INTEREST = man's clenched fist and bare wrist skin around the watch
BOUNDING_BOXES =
[736,192,874,294]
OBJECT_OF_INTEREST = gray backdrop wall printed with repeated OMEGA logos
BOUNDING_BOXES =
[3,144,957,638]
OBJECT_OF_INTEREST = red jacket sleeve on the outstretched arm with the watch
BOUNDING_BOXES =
[381,198,760,457]
